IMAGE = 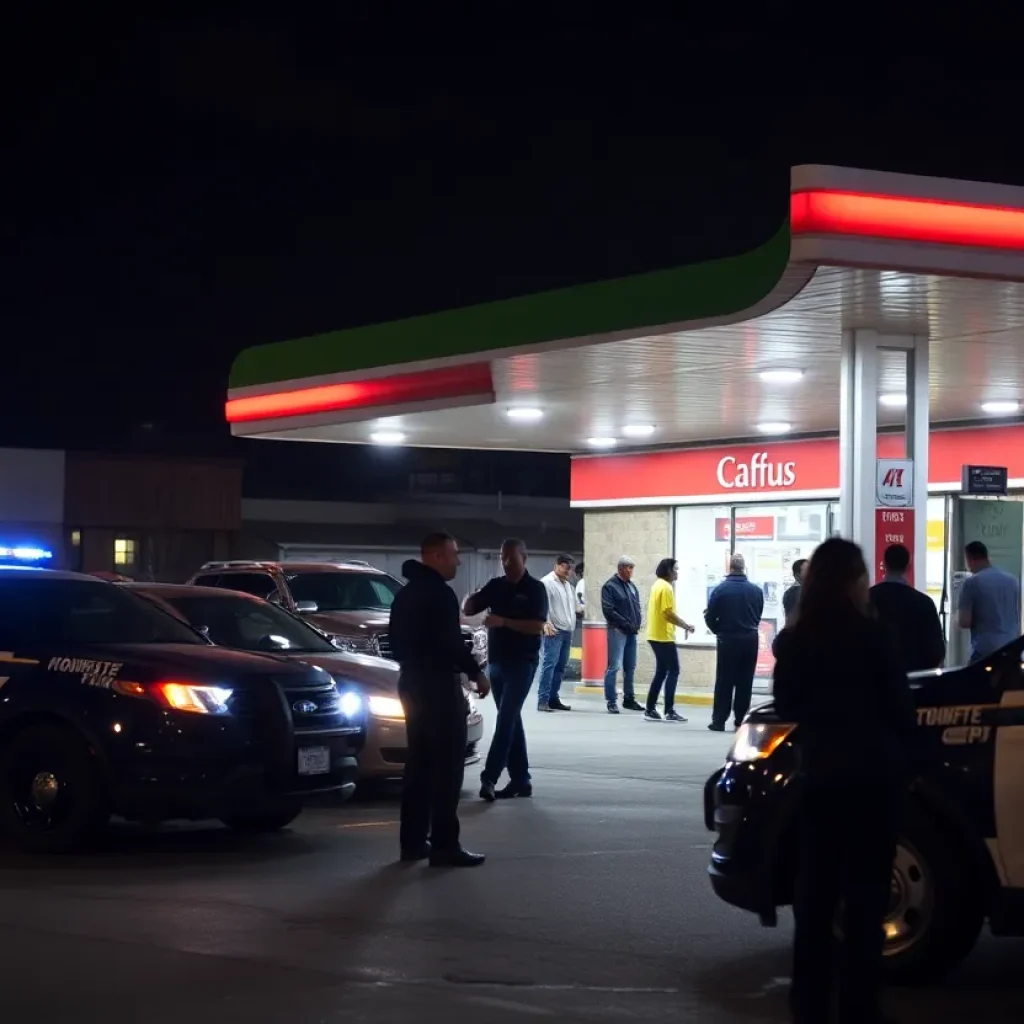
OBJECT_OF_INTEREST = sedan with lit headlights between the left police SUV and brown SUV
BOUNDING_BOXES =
[122,583,483,780]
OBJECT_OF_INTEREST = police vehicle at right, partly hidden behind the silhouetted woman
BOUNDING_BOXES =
[705,638,1024,980]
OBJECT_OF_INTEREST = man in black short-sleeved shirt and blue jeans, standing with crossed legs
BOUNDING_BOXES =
[463,540,548,803]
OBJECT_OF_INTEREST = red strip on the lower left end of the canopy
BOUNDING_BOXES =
[224,362,495,423]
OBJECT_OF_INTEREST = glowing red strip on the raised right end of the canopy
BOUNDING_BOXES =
[790,189,1024,250]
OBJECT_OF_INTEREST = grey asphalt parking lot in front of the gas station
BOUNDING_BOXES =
[0,697,1024,1024]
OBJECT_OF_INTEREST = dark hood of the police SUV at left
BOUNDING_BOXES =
[47,643,323,684]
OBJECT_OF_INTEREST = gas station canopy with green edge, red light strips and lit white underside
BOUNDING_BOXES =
[226,166,1024,453]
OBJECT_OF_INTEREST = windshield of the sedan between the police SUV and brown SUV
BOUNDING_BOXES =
[157,591,338,654]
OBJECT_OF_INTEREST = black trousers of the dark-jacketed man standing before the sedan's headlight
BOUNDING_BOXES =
[398,676,466,850]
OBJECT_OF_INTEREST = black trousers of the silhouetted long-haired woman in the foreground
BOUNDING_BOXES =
[791,785,903,1024]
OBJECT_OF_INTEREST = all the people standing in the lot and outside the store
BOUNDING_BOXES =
[390,534,1021,1024]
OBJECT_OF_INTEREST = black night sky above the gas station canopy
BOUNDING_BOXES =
[8,9,1024,494]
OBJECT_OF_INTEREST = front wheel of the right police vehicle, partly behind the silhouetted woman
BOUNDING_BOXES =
[884,807,985,984]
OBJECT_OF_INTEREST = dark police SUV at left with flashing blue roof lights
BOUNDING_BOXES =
[0,566,366,852]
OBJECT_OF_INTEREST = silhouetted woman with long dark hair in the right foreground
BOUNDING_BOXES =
[774,538,915,1024]
